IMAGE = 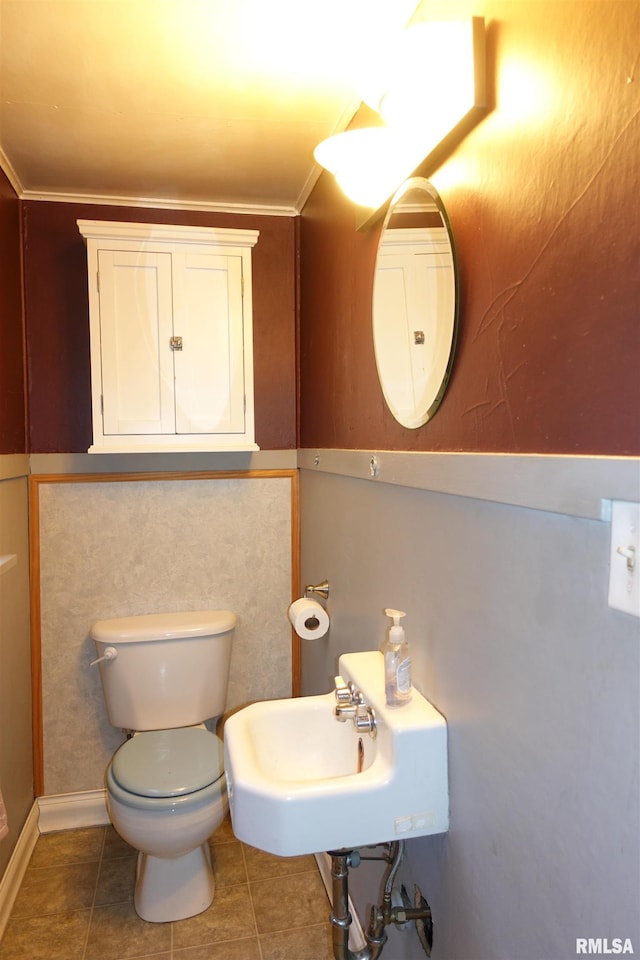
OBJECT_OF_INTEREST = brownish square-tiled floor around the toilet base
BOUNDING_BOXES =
[0,820,333,960]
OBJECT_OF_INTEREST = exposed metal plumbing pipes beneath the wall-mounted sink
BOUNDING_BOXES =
[329,840,431,960]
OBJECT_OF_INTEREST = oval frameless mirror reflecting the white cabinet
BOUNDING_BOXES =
[373,177,458,428]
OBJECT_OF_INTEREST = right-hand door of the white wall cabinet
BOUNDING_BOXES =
[173,252,245,434]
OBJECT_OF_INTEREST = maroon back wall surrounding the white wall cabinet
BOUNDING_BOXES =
[23,201,297,453]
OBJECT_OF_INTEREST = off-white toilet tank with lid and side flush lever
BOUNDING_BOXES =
[90,610,236,730]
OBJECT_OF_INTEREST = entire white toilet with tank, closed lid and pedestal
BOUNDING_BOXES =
[90,610,236,923]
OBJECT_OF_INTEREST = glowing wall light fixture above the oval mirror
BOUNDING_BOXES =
[314,17,485,222]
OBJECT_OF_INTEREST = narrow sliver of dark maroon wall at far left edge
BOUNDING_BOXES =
[0,170,26,454]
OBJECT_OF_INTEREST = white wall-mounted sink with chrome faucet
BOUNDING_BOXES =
[224,651,449,857]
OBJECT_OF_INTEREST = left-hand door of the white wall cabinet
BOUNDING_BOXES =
[98,250,175,435]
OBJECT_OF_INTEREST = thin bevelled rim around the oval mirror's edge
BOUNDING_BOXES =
[371,177,460,430]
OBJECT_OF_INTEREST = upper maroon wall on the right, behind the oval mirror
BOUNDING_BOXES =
[300,0,640,455]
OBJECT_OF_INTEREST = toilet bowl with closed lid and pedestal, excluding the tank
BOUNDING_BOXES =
[106,727,228,922]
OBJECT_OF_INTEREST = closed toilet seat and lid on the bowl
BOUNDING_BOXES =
[107,727,226,810]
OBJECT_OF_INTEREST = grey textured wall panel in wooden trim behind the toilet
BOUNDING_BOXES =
[40,478,291,794]
